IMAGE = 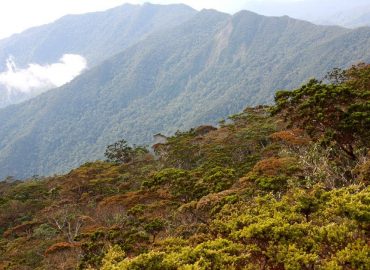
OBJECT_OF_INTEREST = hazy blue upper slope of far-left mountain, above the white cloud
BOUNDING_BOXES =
[0,4,196,71]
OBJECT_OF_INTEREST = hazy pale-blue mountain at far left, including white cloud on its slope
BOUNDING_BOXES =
[0,4,196,108]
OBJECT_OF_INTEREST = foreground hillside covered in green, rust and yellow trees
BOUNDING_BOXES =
[0,65,370,270]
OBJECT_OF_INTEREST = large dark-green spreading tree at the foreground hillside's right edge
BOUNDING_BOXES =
[272,64,370,160]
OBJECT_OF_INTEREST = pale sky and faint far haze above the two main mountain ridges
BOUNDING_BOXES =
[0,0,370,39]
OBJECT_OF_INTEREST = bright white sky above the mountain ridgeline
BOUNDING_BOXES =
[0,0,305,39]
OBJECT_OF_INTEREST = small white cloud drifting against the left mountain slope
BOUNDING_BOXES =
[0,54,87,94]
